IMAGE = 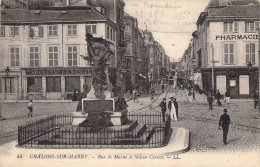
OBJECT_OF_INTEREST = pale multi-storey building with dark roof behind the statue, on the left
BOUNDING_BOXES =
[0,8,117,100]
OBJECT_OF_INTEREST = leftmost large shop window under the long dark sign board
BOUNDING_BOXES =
[27,77,42,93]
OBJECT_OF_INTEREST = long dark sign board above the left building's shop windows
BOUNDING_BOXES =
[25,67,92,75]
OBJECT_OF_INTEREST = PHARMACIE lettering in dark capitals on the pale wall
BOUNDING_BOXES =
[215,34,258,40]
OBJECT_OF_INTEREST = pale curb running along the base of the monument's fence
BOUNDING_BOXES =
[0,127,190,157]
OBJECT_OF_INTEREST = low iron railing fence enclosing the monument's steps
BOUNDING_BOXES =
[18,113,171,148]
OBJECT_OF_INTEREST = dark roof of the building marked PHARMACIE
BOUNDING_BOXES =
[209,5,260,18]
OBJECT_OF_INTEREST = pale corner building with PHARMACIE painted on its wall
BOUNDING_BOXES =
[196,0,260,98]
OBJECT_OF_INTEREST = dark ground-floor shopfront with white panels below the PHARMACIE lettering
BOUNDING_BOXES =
[202,67,258,98]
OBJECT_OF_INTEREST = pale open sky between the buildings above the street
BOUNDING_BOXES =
[124,0,210,62]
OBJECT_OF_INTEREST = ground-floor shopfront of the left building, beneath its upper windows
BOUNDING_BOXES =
[0,67,92,100]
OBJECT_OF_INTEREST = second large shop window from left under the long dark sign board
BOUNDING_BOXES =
[46,77,61,92]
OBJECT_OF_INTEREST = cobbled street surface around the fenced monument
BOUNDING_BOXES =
[0,86,260,152]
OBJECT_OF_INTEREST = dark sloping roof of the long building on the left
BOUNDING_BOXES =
[1,9,114,23]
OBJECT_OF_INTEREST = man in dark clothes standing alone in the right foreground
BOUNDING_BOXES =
[219,108,230,144]
